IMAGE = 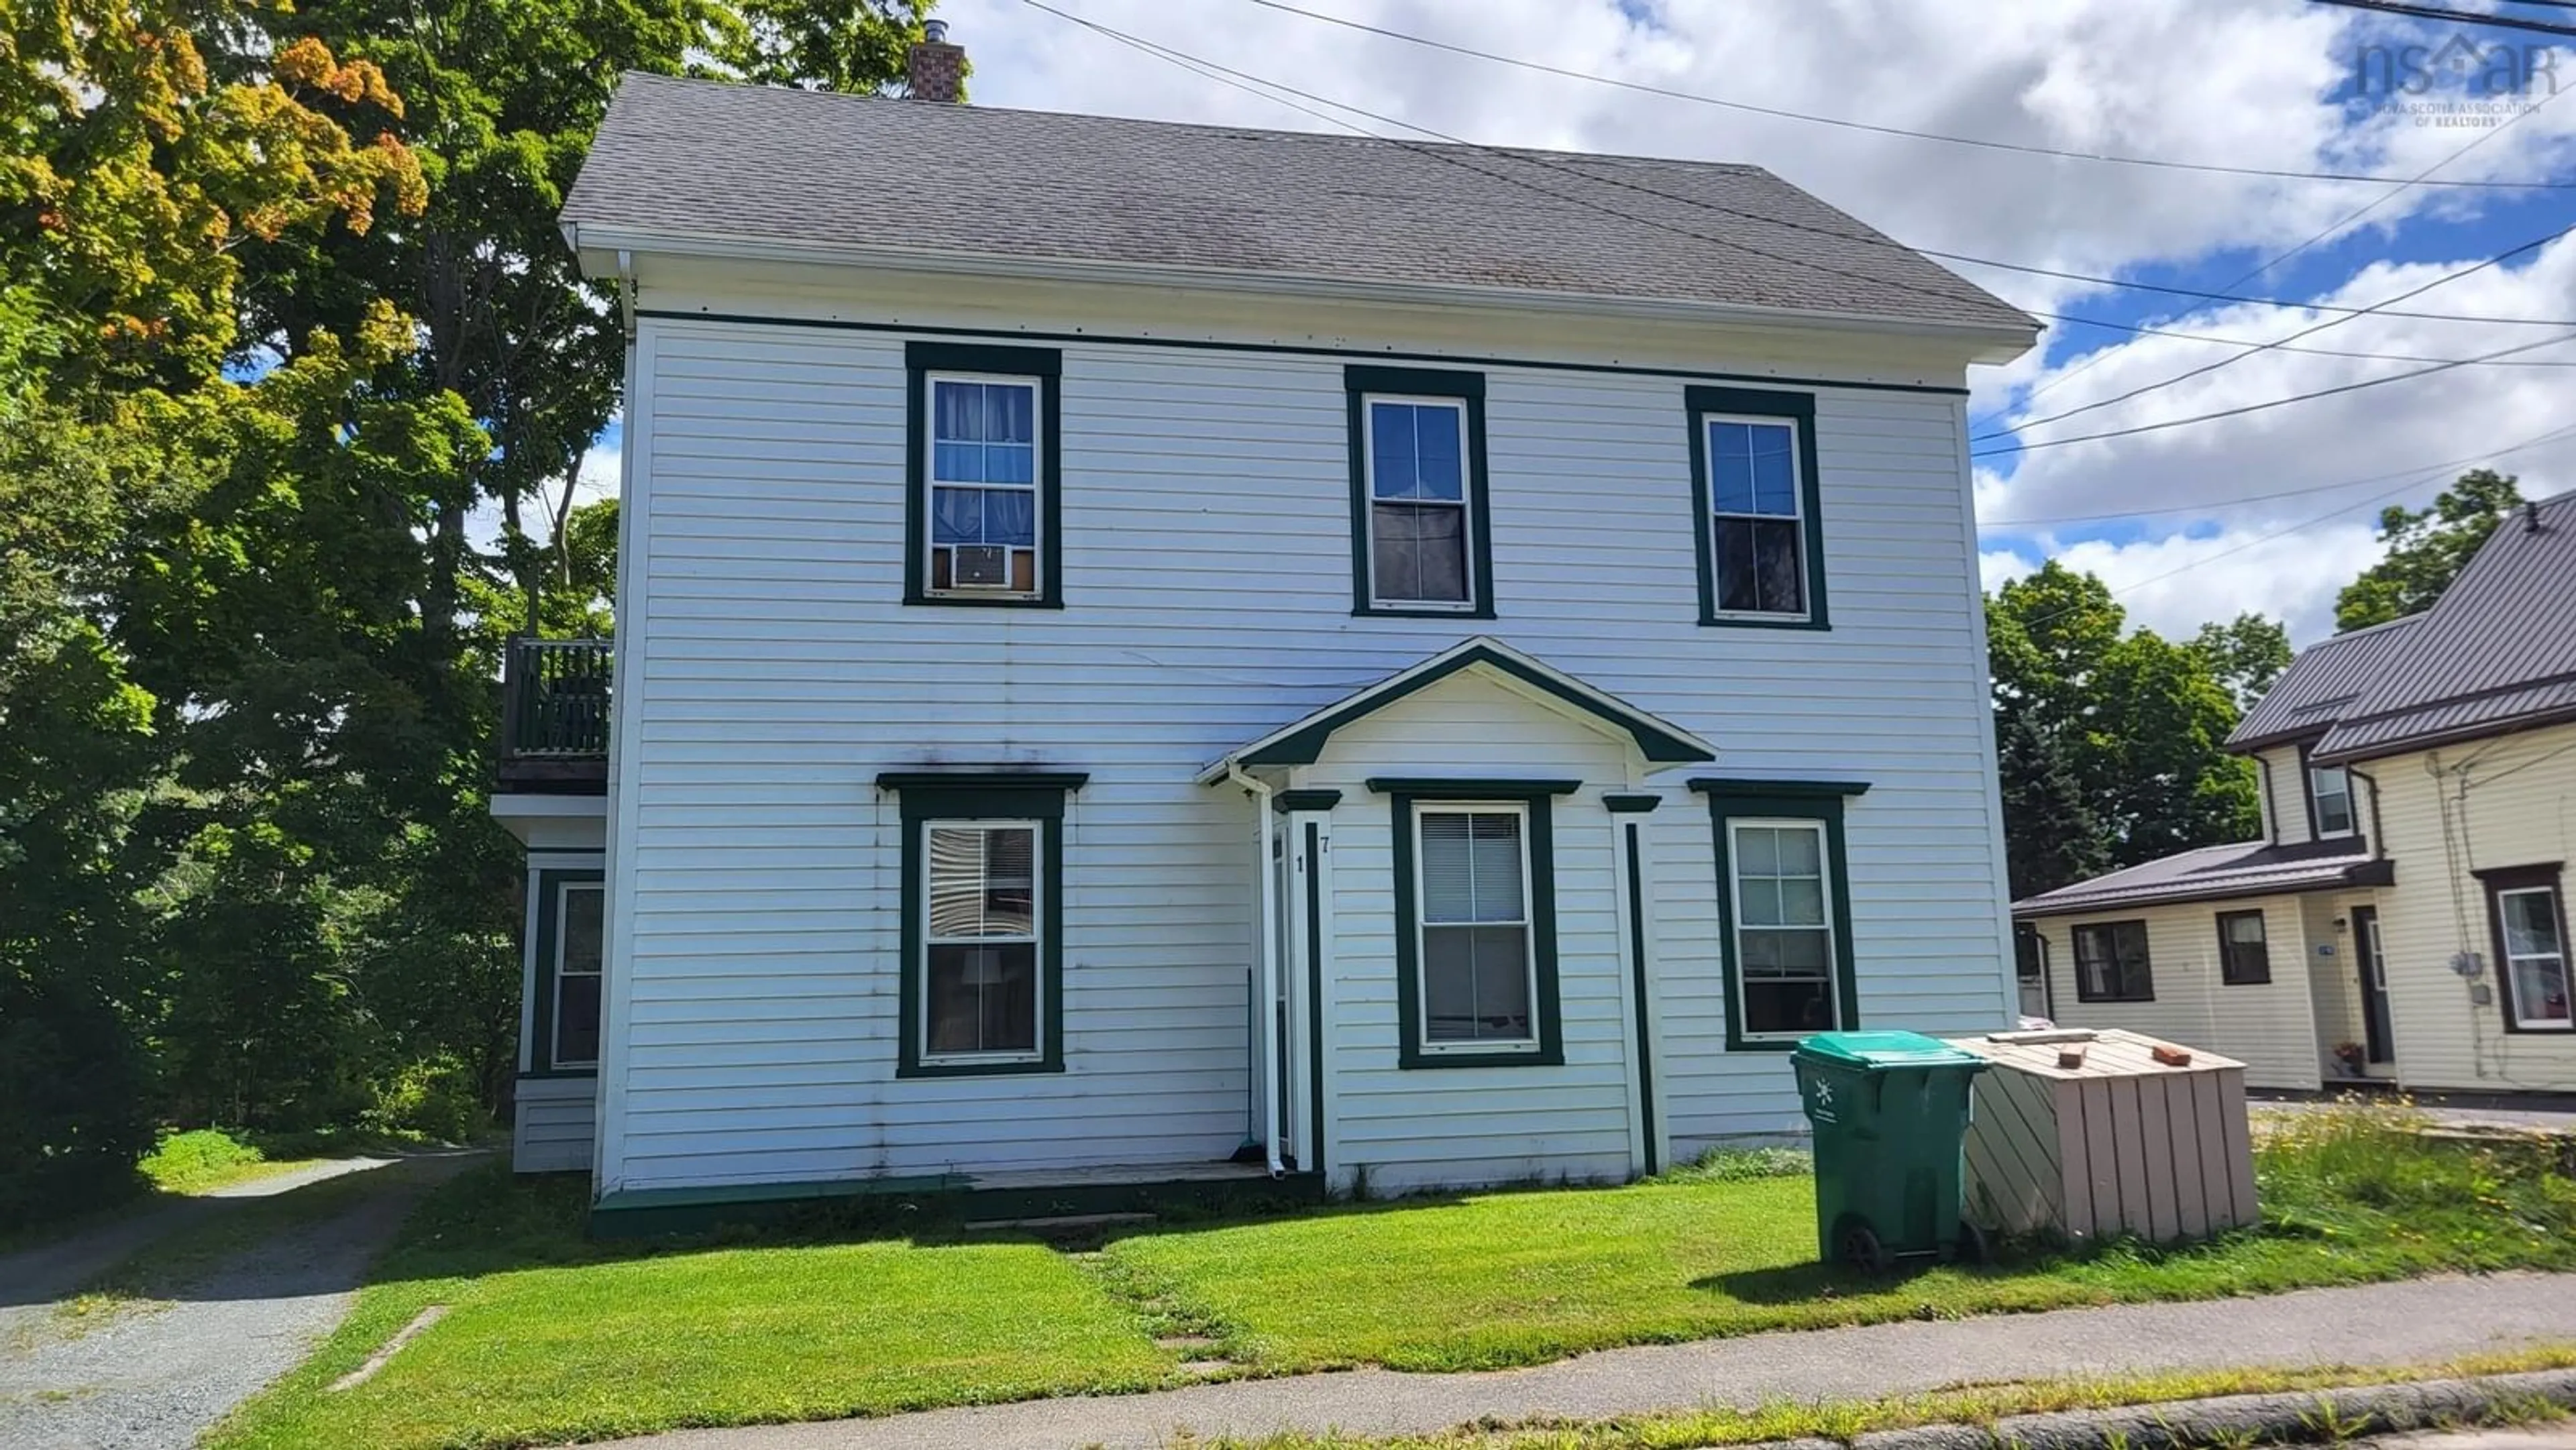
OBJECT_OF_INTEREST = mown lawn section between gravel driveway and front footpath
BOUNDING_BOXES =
[214,1169,1180,1447]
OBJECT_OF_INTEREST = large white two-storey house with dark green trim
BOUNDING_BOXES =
[492,25,2033,1216]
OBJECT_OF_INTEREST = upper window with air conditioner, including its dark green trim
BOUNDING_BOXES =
[904,343,1061,608]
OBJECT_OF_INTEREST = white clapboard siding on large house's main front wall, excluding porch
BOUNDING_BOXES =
[600,296,2009,1190]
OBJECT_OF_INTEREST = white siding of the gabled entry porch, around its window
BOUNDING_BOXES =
[1296,669,1635,1190]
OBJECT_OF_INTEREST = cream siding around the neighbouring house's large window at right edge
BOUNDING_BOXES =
[2359,726,2576,1092]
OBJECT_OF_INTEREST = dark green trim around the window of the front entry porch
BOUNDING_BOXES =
[1368,778,1579,1069]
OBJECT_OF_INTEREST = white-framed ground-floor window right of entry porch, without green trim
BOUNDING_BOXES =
[1726,819,1842,1038]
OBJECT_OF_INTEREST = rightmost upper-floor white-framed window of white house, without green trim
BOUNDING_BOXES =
[1700,414,1809,618]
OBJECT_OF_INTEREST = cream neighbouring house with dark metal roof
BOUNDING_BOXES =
[2015,494,2576,1092]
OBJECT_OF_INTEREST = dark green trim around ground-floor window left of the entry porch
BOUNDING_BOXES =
[876,770,1089,1079]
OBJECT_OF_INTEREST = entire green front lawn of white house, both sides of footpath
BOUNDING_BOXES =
[214,1113,2576,1447]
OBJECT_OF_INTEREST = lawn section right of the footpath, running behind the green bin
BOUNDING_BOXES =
[1108,1110,2576,1370]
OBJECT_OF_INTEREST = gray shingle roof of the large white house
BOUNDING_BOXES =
[564,74,2035,332]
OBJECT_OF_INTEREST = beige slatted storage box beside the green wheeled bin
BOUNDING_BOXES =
[1955,1030,2259,1244]
